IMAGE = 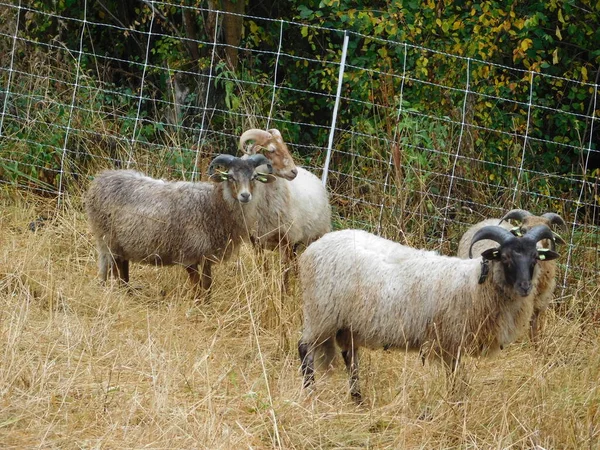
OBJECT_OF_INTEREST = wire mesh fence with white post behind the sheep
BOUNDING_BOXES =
[0,1,600,287]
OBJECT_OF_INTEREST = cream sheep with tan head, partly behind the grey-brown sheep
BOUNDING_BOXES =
[239,129,331,290]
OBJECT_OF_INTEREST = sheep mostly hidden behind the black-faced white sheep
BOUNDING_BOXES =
[457,209,567,344]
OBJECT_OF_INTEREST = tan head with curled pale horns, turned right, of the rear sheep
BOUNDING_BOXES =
[239,128,298,181]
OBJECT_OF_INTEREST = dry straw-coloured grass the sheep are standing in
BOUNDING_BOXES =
[0,188,600,449]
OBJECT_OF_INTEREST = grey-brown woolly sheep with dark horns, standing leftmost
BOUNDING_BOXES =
[85,154,276,293]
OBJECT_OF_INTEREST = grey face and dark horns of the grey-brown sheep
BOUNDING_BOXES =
[210,155,276,204]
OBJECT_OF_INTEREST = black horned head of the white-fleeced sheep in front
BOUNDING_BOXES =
[469,225,560,297]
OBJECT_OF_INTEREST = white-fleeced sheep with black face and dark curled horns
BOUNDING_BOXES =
[298,225,559,402]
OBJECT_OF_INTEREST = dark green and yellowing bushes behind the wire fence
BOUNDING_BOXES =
[0,0,600,270]
